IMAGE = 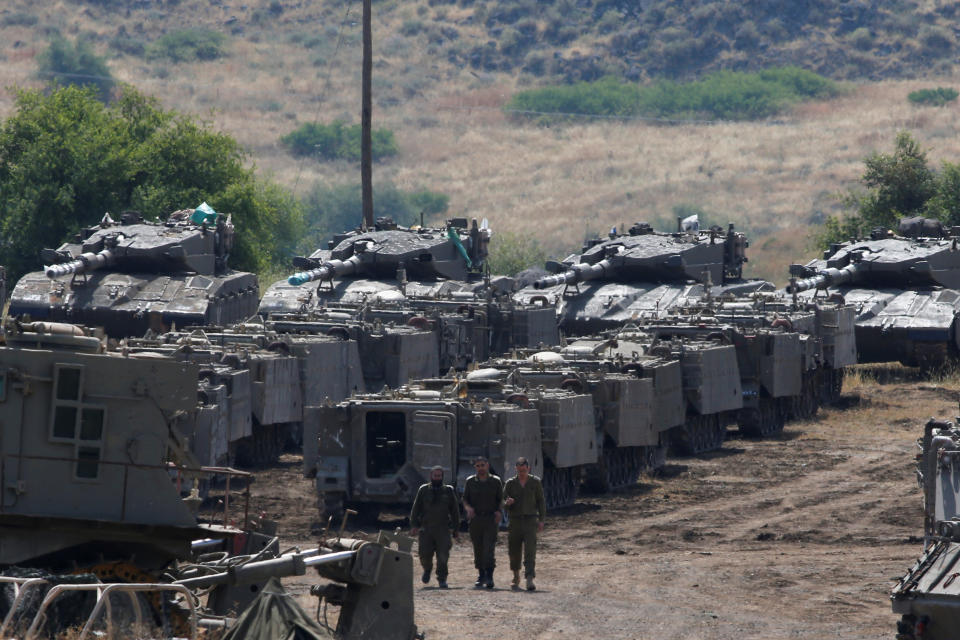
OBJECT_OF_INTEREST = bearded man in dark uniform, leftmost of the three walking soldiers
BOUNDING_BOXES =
[410,466,460,589]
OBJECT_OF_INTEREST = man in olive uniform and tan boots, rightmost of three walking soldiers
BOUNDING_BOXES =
[503,457,547,591]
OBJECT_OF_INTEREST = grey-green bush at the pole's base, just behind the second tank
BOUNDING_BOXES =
[303,183,450,247]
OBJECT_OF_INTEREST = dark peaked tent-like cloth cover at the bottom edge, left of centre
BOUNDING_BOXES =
[222,578,334,640]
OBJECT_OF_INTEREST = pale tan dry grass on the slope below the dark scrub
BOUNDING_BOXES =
[0,0,960,282]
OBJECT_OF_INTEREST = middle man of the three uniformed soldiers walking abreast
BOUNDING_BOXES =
[463,456,503,589]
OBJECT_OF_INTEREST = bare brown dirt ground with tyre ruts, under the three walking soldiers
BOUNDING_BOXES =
[254,381,960,640]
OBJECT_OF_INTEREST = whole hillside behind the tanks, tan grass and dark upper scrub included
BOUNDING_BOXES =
[0,0,960,281]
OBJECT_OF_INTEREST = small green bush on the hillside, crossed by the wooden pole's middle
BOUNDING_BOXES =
[280,120,399,161]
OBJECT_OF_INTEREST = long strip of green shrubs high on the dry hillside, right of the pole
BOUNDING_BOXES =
[506,67,840,122]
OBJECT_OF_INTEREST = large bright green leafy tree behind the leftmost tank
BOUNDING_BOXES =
[0,87,303,278]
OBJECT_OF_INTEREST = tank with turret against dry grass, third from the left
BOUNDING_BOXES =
[515,222,774,335]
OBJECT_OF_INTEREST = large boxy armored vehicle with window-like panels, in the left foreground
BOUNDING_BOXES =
[0,322,236,568]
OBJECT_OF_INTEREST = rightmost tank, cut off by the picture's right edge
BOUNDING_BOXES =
[787,224,960,368]
